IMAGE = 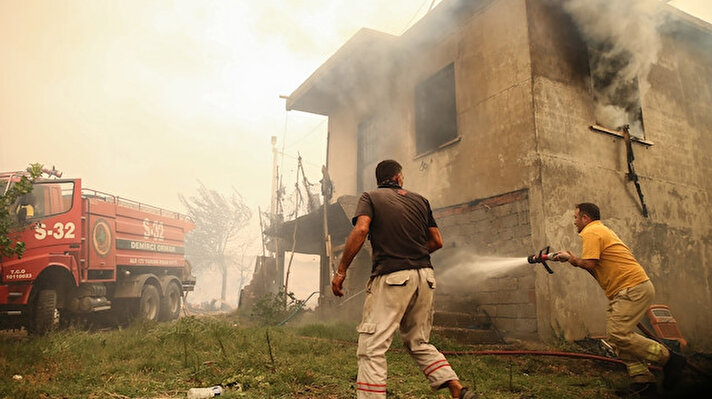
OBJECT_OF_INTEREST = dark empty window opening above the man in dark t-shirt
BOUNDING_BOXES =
[415,64,457,154]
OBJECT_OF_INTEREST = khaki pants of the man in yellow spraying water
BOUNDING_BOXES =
[606,280,670,382]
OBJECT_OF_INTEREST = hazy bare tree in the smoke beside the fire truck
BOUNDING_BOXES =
[179,181,252,301]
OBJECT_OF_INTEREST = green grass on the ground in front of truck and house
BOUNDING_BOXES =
[0,317,692,399]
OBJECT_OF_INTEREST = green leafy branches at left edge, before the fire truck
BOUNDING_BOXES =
[0,163,42,257]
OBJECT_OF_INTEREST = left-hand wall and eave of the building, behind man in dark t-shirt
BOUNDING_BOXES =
[288,1,537,335]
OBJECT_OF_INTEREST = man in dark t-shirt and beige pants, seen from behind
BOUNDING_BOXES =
[331,160,476,399]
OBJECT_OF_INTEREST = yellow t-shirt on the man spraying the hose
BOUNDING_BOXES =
[579,220,649,299]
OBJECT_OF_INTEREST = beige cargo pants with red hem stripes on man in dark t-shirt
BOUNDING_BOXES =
[356,268,457,399]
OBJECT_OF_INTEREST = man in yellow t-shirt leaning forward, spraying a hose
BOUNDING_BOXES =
[554,203,686,393]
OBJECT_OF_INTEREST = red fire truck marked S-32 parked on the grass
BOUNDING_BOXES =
[0,172,195,333]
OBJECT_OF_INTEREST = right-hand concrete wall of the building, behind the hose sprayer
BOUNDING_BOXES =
[527,0,712,350]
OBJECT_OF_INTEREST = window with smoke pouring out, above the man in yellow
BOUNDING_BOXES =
[588,43,645,139]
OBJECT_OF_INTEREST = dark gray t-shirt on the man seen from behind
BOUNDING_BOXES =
[352,186,438,276]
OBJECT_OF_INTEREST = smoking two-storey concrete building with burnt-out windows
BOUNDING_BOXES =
[280,0,712,350]
